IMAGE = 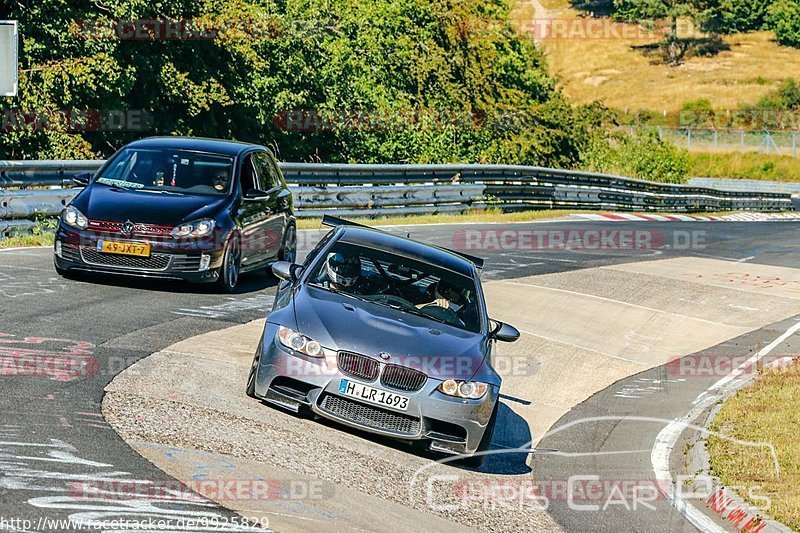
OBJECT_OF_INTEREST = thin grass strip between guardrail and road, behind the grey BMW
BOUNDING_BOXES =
[297,209,599,229]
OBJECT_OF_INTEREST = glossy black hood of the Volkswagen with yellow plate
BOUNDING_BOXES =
[72,185,226,226]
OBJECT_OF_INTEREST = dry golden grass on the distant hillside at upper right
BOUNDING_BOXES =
[514,0,800,113]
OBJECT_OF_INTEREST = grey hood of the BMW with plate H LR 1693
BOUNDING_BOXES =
[294,285,489,379]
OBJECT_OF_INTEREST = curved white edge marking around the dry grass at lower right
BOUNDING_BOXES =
[650,322,800,533]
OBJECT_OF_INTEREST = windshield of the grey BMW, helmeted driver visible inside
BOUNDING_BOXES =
[308,242,481,333]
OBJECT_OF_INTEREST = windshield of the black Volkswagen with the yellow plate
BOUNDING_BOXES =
[95,148,233,195]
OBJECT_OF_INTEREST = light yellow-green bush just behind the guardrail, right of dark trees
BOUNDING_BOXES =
[584,131,689,183]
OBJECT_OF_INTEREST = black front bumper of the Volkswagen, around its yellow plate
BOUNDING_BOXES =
[54,224,223,283]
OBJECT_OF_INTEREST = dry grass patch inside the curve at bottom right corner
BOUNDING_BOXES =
[708,364,800,531]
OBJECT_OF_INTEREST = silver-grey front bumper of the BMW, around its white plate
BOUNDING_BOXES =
[255,323,499,455]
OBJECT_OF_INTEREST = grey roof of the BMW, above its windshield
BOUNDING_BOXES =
[338,226,475,278]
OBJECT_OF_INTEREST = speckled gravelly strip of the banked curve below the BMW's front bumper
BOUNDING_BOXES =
[103,352,559,531]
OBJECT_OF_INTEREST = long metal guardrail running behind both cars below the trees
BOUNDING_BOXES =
[0,161,793,236]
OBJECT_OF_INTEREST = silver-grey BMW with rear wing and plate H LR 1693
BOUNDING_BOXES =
[246,217,519,466]
